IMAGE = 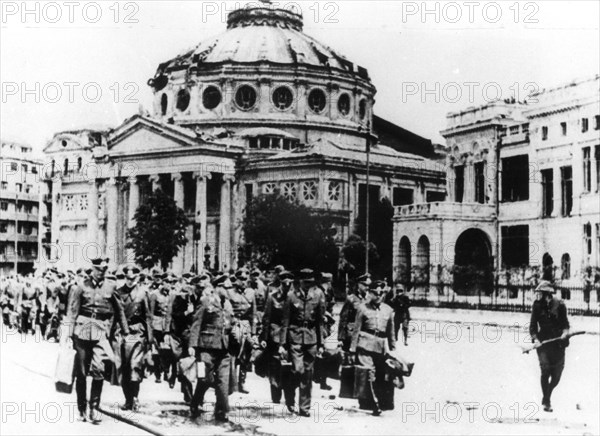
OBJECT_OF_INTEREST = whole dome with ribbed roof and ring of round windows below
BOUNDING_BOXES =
[148,3,377,149]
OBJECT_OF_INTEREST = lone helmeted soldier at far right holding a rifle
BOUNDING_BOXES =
[529,280,570,412]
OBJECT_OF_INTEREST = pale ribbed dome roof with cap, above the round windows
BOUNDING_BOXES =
[157,8,368,80]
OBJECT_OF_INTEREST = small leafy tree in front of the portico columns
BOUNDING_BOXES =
[126,190,189,270]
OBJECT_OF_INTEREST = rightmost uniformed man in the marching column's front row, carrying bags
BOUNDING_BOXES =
[350,280,396,416]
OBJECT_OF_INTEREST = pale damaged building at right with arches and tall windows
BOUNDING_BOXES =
[394,76,600,294]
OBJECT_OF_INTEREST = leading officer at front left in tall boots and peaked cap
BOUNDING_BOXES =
[61,259,129,424]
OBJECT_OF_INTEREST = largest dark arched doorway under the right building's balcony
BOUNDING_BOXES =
[454,229,493,295]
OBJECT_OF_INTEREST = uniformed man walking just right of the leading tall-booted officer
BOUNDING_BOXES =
[117,266,154,411]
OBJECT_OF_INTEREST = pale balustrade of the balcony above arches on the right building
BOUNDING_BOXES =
[394,201,496,220]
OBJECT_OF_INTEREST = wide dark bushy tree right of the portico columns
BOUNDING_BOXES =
[241,195,339,272]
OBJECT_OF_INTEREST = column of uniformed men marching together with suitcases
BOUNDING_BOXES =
[0,258,410,424]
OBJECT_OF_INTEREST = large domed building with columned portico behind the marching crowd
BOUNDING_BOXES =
[45,5,445,272]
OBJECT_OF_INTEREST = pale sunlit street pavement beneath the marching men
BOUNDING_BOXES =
[0,314,600,435]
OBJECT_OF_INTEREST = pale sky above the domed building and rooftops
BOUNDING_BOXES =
[0,0,600,155]
